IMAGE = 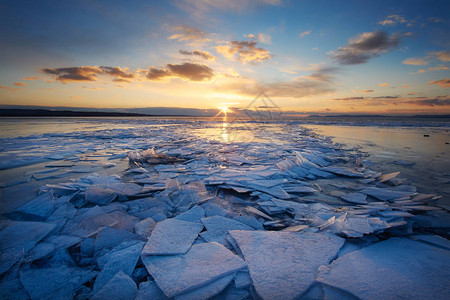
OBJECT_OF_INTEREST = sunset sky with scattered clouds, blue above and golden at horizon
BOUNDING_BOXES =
[0,0,450,116]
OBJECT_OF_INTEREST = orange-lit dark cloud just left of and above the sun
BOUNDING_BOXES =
[146,63,214,81]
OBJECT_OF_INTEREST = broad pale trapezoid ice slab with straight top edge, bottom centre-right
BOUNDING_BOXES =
[230,230,345,299]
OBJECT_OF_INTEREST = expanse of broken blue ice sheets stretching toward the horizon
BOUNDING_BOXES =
[0,120,450,299]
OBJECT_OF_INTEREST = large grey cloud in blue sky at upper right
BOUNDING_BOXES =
[331,31,409,65]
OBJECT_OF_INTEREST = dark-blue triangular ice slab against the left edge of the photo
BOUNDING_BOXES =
[0,221,56,274]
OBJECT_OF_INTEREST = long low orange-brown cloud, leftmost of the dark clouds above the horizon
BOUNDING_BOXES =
[41,66,135,83]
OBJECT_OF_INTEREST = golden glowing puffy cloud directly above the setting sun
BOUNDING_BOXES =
[216,41,272,63]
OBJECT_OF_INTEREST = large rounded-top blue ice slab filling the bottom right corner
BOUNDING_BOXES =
[318,238,450,299]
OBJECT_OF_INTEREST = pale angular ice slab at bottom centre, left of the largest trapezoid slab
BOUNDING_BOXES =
[142,243,246,297]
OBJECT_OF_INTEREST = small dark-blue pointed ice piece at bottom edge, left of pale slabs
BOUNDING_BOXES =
[91,271,137,300]
